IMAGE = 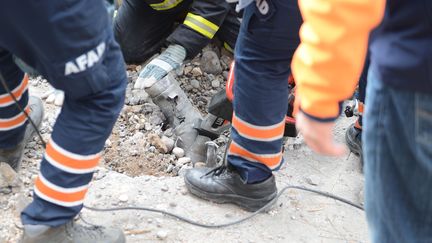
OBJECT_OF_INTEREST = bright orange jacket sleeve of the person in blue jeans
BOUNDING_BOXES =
[292,0,385,121]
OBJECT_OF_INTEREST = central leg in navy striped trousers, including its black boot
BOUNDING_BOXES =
[185,1,302,211]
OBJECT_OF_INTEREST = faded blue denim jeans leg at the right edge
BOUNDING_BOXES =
[363,68,432,243]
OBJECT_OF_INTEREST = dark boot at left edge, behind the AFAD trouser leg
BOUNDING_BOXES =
[0,96,44,170]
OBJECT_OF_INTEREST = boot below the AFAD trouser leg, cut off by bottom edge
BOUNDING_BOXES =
[19,221,126,243]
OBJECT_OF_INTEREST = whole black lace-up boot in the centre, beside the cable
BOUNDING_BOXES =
[185,165,277,211]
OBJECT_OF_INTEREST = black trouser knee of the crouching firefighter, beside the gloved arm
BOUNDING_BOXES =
[114,0,178,63]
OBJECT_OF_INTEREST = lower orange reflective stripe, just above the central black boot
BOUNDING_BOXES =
[229,141,282,169]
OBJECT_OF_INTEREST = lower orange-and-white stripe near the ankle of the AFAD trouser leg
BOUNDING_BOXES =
[35,176,88,205]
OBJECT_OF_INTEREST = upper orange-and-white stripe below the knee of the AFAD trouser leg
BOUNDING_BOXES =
[45,140,101,173]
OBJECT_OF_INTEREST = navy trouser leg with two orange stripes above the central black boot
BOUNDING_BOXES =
[228,0,302,183]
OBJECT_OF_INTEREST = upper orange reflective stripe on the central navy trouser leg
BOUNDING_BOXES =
[232,113,285,141]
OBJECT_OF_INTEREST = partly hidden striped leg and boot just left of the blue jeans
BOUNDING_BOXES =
[345,55,370,164]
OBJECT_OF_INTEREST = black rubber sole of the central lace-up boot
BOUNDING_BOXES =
[185,179,277,212]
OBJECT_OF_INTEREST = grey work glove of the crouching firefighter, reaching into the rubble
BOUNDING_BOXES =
[134,44,186,89]
